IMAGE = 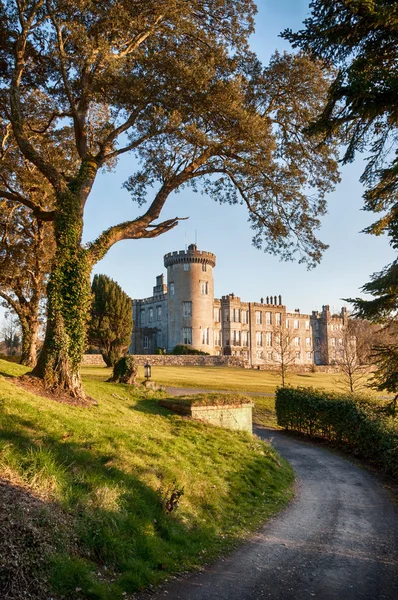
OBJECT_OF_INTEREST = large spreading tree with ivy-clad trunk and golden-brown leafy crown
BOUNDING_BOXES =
[0,0,338,396]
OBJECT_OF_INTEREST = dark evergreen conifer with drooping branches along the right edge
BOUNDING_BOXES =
[283,0,398,408]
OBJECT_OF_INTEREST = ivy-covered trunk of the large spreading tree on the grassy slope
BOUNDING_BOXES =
[33,189,91,399]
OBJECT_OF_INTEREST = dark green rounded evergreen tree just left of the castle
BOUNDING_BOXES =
[88,275,133,367]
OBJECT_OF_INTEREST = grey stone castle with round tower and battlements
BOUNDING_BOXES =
[130,244,348,367]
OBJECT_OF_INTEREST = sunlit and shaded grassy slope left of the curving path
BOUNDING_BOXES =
[0,361,293,600]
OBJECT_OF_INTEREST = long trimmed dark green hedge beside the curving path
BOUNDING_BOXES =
[275,387,398,477]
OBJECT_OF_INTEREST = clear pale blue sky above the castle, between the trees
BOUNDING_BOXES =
[0,0,394,328]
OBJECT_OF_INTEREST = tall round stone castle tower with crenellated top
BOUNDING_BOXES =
[164,244,216,353]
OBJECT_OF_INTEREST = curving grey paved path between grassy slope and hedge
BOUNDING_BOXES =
[143,428,398,600]
